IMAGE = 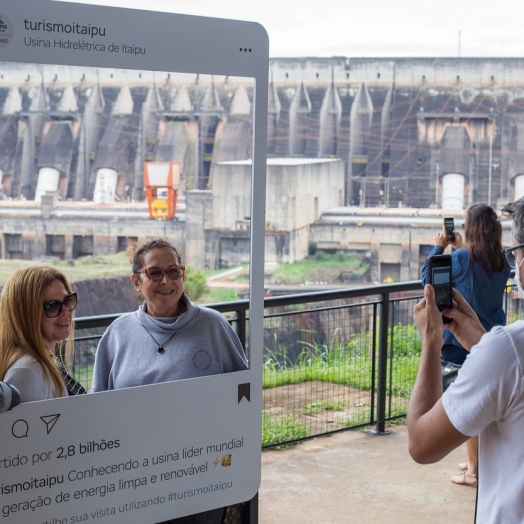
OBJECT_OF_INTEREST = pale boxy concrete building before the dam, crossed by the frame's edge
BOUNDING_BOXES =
[211,158,344,267]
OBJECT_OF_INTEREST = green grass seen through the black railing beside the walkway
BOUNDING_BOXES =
[263,324,421,445]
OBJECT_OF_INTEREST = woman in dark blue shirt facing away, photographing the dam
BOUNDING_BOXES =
[422,204,511,487]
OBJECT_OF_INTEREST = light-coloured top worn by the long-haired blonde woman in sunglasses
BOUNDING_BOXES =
[4,355,67,403]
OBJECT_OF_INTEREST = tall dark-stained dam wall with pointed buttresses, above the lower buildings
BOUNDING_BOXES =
[0,57,524,208]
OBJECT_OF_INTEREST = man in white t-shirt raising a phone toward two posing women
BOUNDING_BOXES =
[408,199,524,524]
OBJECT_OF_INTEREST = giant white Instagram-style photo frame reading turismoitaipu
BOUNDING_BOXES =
[0,0,268,524]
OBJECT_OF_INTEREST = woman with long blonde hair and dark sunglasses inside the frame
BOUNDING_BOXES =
[0,266,85,402]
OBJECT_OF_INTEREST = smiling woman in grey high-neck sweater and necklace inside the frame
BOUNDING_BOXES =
[93,239,247,524]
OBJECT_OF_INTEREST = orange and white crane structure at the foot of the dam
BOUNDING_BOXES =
[144,162,182,220]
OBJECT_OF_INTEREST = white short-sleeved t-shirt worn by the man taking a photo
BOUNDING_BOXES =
[442,321,524,524]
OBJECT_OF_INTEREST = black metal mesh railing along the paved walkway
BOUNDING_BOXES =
[75,281,520,448]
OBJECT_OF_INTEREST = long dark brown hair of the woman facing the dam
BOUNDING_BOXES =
[464,204,506,273]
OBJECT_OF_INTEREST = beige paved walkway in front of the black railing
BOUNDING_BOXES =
[259,426,476,524]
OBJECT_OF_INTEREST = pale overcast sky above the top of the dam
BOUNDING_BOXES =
[56,0,524,57]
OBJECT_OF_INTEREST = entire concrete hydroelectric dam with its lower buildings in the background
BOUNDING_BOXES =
[0,57,524,281]
